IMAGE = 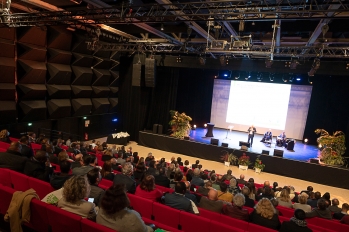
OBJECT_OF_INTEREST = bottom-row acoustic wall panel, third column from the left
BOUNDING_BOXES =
[47,99,71,119]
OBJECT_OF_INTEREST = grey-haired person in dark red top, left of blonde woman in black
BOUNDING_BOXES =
[223,193,249,222]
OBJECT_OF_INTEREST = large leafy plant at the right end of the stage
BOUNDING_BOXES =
[315,129,346,165]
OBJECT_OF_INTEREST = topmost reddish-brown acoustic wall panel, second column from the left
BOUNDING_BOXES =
[17,26,47,47]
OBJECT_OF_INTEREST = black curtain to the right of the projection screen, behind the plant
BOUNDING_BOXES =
[304,76,349,152]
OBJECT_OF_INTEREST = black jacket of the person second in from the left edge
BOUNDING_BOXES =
[23,158,53,182]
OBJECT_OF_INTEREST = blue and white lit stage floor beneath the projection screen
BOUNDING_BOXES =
[190,128,319,162]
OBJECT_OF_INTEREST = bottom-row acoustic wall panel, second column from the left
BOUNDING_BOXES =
[19,100,46,122]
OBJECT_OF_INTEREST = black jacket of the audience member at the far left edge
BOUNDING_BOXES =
[0,150,28,173]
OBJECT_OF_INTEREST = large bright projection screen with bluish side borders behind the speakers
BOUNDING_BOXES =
[211,79,312,139]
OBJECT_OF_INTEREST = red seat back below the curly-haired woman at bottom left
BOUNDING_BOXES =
[47,205,81,232]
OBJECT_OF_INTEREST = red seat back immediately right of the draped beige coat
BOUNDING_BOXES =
[26,199,49,232]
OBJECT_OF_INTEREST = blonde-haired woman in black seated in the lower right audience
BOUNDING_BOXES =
[250,198,280,230]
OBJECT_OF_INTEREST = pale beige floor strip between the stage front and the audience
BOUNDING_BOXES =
[92,137,349,205]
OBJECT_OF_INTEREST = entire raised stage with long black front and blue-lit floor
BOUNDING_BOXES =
[138,129,349,189]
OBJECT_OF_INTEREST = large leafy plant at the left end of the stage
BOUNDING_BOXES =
[169,110,192,139]
